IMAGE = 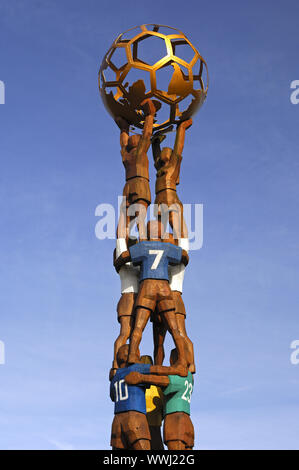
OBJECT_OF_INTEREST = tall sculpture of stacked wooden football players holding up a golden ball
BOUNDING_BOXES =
[99,24,208,450]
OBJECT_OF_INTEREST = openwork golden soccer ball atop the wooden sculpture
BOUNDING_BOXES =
[99,24,208,130]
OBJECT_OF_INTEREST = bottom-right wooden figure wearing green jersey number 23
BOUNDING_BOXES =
[125,349,194,450]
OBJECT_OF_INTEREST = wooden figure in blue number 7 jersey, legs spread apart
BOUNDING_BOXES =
[115,221,189,366]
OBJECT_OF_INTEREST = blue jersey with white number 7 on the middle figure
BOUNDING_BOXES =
[130,241,182,281]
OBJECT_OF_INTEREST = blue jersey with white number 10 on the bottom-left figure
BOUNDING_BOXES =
[110,364,151,414]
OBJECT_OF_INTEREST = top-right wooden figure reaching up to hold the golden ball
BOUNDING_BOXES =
[152,119,192,239]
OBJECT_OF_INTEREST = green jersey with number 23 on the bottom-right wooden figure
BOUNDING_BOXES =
[163,372,194,415]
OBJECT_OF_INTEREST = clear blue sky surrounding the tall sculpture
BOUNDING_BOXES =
[0,0,299,449]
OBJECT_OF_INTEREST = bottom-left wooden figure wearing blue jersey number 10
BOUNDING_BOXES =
[110,344,151,450]
